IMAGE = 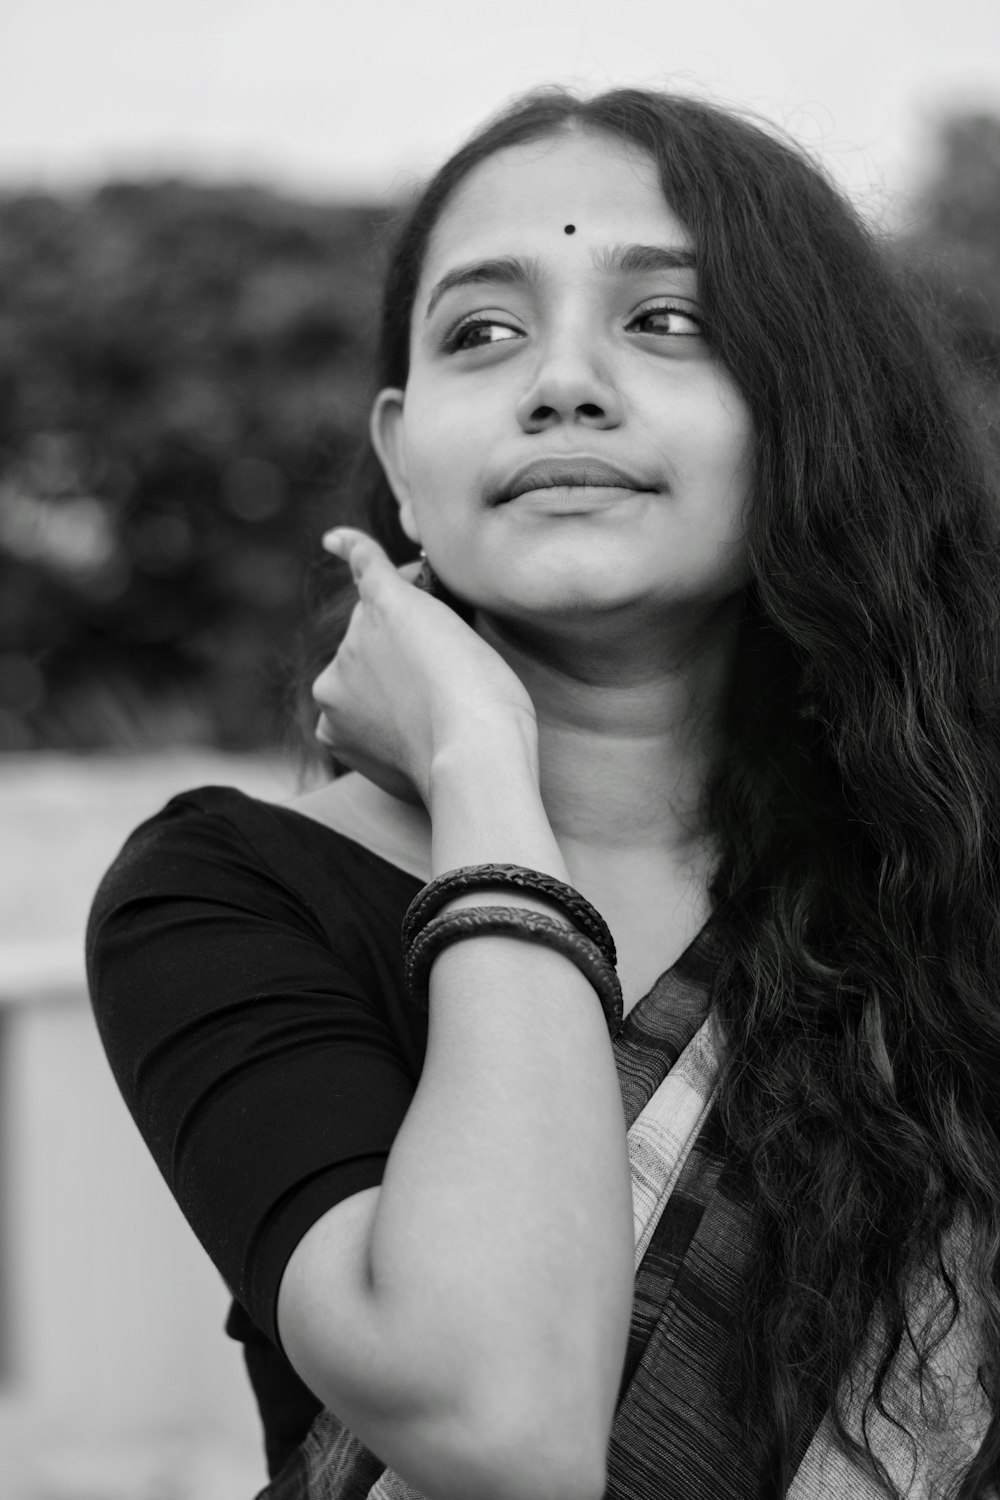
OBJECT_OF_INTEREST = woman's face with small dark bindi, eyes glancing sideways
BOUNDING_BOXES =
[372,123,753,621]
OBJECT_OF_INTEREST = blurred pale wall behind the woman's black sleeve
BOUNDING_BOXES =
[0,753,305,1500]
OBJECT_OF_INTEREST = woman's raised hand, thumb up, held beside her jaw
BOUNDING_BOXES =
[312,527,537,807]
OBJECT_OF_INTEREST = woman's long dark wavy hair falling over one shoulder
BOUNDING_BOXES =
[289,89,1000,1500]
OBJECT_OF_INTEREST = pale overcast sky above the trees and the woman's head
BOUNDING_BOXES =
[0,0,1000,224]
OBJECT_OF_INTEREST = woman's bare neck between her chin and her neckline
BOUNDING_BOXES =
[475,597,742,864]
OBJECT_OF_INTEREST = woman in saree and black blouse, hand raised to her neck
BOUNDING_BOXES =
[88,90,1000,1500]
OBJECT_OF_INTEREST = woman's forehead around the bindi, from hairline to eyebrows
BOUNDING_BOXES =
[420,131,694,287]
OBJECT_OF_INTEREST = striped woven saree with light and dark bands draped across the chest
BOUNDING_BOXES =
[256,921,990,1500]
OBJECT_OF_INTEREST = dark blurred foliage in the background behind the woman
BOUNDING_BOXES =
[0,114,1000,750]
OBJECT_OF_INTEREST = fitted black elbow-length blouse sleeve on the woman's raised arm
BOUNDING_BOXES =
[87,794,426,1347]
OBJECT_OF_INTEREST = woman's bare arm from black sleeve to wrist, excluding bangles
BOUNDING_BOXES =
[279,723,633,1500]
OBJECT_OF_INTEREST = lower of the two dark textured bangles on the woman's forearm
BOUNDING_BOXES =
[405,906,624,1040]
